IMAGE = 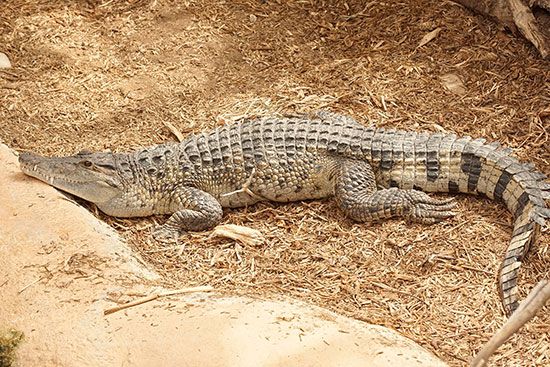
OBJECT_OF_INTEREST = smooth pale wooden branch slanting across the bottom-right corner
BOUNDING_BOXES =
[470,280,550,367]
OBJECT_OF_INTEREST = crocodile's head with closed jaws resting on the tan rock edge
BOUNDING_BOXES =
[19,152,124,204]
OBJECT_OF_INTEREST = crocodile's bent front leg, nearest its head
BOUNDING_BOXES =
[153,186,223,242]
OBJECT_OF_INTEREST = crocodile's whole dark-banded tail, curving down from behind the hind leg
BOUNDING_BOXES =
[361,129,550,315]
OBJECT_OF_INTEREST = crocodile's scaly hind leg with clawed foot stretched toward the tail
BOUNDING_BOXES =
[334,160,456,224]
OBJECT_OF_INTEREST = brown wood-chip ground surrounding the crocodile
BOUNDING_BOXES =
[0,0,550,366]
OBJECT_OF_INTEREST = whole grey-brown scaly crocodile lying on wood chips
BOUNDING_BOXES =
[19,111,550,315]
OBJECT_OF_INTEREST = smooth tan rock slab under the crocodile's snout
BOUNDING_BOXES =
[0,145,445,367]
